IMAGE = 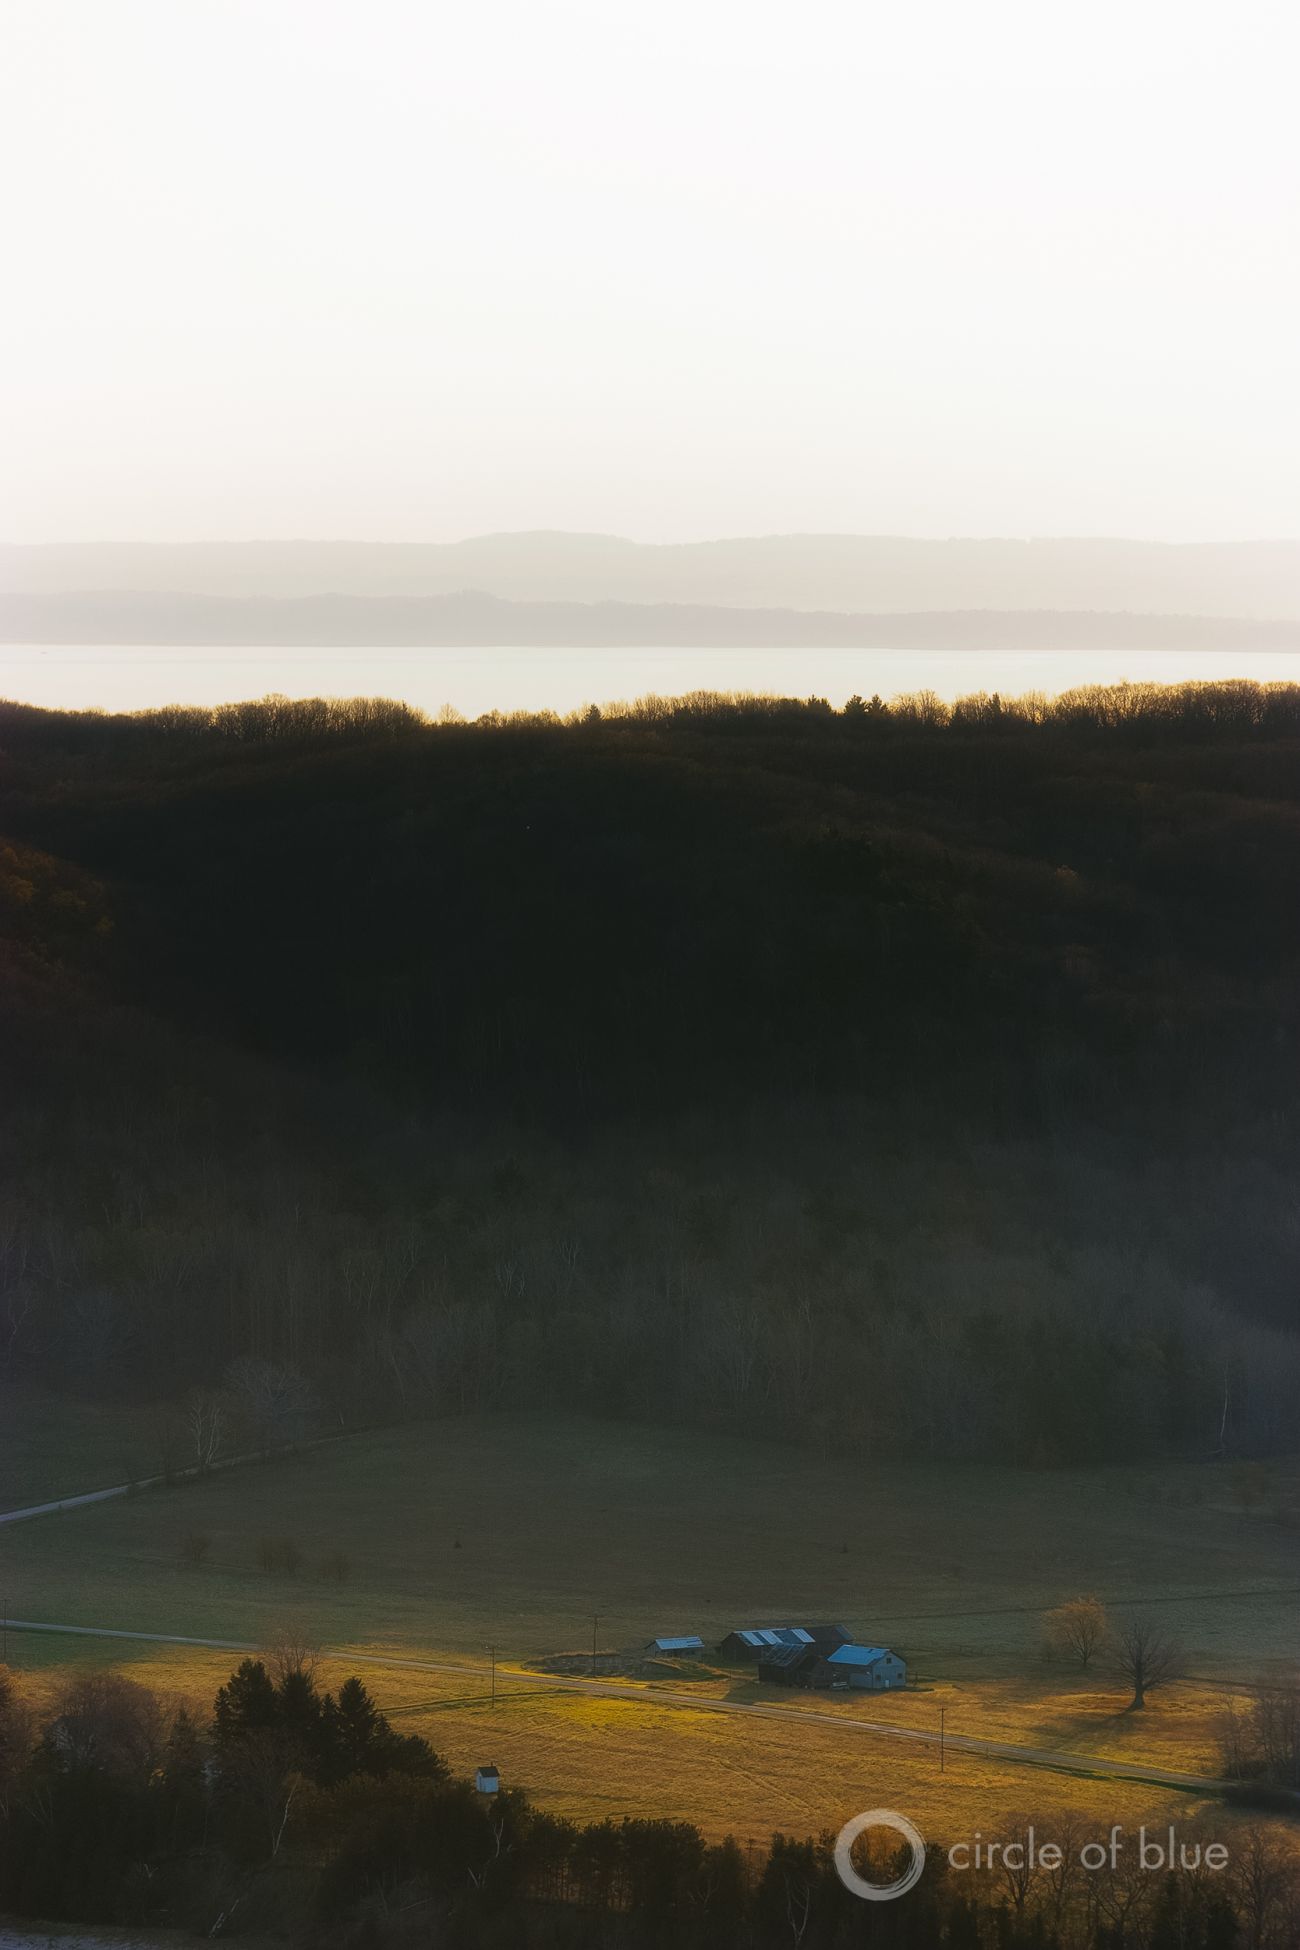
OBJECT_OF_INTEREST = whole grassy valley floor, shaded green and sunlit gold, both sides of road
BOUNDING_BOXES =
[0,1418,1300,1835]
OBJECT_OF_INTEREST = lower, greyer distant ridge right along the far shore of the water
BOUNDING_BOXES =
[0,591,1300,655]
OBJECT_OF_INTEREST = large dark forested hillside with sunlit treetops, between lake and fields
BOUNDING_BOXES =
[0,684,1300,1464]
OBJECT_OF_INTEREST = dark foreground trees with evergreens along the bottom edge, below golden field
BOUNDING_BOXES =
[0,1646,1300,1950]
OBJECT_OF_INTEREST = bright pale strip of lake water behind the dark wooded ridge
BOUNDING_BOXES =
[0,644,1300,718]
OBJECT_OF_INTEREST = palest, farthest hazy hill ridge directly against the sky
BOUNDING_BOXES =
[0,530,1300,618]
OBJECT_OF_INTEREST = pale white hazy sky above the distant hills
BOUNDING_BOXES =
[0,0,1300,540]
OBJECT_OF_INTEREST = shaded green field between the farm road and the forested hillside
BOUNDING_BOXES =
[0,1416,1300,1681]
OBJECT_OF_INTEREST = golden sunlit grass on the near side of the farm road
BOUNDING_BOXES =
[7,1640,1247,1843]
